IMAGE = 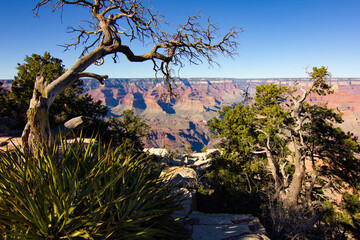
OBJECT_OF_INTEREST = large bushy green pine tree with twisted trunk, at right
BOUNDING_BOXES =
[203,67,360,239]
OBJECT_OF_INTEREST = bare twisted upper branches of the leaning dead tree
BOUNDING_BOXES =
[34,0,242,87]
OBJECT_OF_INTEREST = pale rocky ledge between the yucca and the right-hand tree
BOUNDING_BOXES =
[159,153,269,240]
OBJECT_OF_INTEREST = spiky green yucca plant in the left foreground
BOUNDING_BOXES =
[0,138,183,239]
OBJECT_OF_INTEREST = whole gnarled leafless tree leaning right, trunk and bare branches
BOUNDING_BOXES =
[22,0,241,149]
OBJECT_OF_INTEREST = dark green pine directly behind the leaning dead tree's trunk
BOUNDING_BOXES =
[9,52,108,129]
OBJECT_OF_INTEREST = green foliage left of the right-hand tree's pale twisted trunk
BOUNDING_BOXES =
[207,84,289,210]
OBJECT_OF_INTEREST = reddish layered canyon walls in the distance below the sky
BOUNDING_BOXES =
[80,78,360,152]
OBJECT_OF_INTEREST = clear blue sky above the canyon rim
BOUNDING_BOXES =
[0,0,360,79]
